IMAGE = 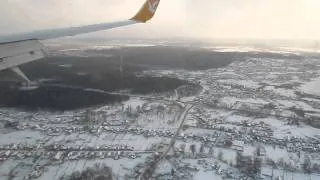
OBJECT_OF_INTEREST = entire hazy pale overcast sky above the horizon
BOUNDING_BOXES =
[0,0,320,39]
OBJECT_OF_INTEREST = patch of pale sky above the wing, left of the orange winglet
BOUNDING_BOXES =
[0,0,144,33]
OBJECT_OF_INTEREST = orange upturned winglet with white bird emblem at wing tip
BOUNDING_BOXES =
[130,0,160,23]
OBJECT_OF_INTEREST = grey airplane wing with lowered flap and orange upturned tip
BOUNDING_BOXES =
[0,0,160,82]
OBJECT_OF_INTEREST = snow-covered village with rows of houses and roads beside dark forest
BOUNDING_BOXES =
[0,53,320,180]
